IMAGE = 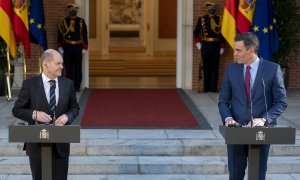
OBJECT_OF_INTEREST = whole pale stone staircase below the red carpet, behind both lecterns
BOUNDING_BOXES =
[0,129,300,180]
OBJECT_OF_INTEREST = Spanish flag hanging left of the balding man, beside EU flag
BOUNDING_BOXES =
[12,0,30,57]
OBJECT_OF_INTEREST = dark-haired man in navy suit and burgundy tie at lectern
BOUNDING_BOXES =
[218,32,287,180]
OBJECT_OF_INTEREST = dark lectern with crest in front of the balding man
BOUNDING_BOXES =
[8,124,80,180]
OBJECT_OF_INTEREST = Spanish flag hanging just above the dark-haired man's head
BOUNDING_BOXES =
[236,0,256,32]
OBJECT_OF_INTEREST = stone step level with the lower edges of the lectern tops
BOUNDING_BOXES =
[0,139,300,156]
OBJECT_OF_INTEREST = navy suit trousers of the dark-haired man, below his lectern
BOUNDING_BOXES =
[227,144,270,180]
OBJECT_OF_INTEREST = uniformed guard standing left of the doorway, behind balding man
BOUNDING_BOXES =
[57,3,88,92]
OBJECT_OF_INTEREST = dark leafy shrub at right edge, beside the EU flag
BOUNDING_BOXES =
[272,0,300,88]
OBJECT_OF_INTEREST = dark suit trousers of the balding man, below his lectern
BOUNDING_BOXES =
[29,149,69,180]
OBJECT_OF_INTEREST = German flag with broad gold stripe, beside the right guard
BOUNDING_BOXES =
[221,0,238,48]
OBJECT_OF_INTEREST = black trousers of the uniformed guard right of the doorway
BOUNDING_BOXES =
[201,42,220,92]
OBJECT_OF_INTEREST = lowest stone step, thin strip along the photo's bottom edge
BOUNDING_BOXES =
[0,174,300,180]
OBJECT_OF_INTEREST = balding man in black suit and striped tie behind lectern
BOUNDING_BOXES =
[12,49,79,180]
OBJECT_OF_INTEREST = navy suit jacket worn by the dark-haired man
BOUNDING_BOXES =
[218,59,287,125]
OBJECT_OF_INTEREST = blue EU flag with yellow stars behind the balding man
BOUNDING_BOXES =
[29,0,48,50]
